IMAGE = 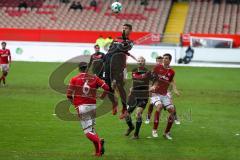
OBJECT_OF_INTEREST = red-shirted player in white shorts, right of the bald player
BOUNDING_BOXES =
[150,53,175,140]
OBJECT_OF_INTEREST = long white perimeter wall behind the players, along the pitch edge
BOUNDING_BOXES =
[5,41,240,67]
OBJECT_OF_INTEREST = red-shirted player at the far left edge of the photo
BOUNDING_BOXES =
[0,42,11,85]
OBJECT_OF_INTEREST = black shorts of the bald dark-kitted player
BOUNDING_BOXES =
[127,95,148,113]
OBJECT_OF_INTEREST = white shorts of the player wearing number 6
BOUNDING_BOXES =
[77,104,96,133]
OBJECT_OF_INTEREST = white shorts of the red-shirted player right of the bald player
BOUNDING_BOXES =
[151,94,174,109]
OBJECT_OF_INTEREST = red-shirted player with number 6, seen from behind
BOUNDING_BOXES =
[67,62,109,156]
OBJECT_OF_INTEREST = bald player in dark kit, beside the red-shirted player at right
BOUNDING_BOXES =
[125,57,151,139]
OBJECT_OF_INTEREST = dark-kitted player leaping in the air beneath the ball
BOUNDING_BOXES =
[104,24,135,119]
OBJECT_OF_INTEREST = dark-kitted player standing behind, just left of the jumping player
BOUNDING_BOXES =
[88,44,105,79]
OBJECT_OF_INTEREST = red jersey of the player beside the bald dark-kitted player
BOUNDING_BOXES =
[153,64,175,95]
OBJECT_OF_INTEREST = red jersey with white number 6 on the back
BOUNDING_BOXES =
[67,73,109,107]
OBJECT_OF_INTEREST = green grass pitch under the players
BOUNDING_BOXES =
[0,62,240,160]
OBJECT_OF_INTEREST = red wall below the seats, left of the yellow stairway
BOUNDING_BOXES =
[0,28,149,43]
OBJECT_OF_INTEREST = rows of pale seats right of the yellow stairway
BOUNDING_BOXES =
[184,0,240,34]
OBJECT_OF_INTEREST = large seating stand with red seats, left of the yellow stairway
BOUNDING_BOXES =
[0,0,172,33]
